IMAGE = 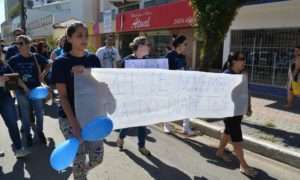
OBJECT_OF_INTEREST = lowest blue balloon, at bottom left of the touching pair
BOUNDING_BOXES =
[50,138,80,171]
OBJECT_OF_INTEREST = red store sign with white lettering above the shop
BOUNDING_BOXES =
[116,0,194,32]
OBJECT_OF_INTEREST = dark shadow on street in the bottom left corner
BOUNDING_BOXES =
[0,138,72,180]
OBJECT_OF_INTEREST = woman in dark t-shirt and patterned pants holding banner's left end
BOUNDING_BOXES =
[52,22,104,180]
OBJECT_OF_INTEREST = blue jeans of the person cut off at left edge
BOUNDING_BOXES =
[0,94,22,150]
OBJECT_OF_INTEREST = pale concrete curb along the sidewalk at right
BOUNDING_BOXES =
[191,119,300,169]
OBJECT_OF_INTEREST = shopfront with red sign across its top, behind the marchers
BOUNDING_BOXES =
[116,0,197,67]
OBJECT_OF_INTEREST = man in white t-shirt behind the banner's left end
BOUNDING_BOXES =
[96,36,121,68]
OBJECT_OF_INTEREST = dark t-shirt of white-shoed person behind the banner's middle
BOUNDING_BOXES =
[166,51,187,70]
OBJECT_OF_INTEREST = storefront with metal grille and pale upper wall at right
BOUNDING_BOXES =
[223,0,300,96]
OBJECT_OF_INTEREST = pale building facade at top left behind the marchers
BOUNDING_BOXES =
[1,0,100,49]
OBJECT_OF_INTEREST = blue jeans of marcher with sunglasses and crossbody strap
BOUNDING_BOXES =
[16,90,44,137]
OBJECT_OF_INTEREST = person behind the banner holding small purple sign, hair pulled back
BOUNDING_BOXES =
[117,36,151,156]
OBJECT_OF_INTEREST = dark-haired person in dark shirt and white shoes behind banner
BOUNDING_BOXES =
[164,36,200,136]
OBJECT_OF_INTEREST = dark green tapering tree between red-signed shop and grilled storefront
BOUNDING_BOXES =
[191,0,241,71]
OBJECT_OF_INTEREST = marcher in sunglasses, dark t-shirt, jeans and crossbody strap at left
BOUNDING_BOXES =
[8,35,50,146]
